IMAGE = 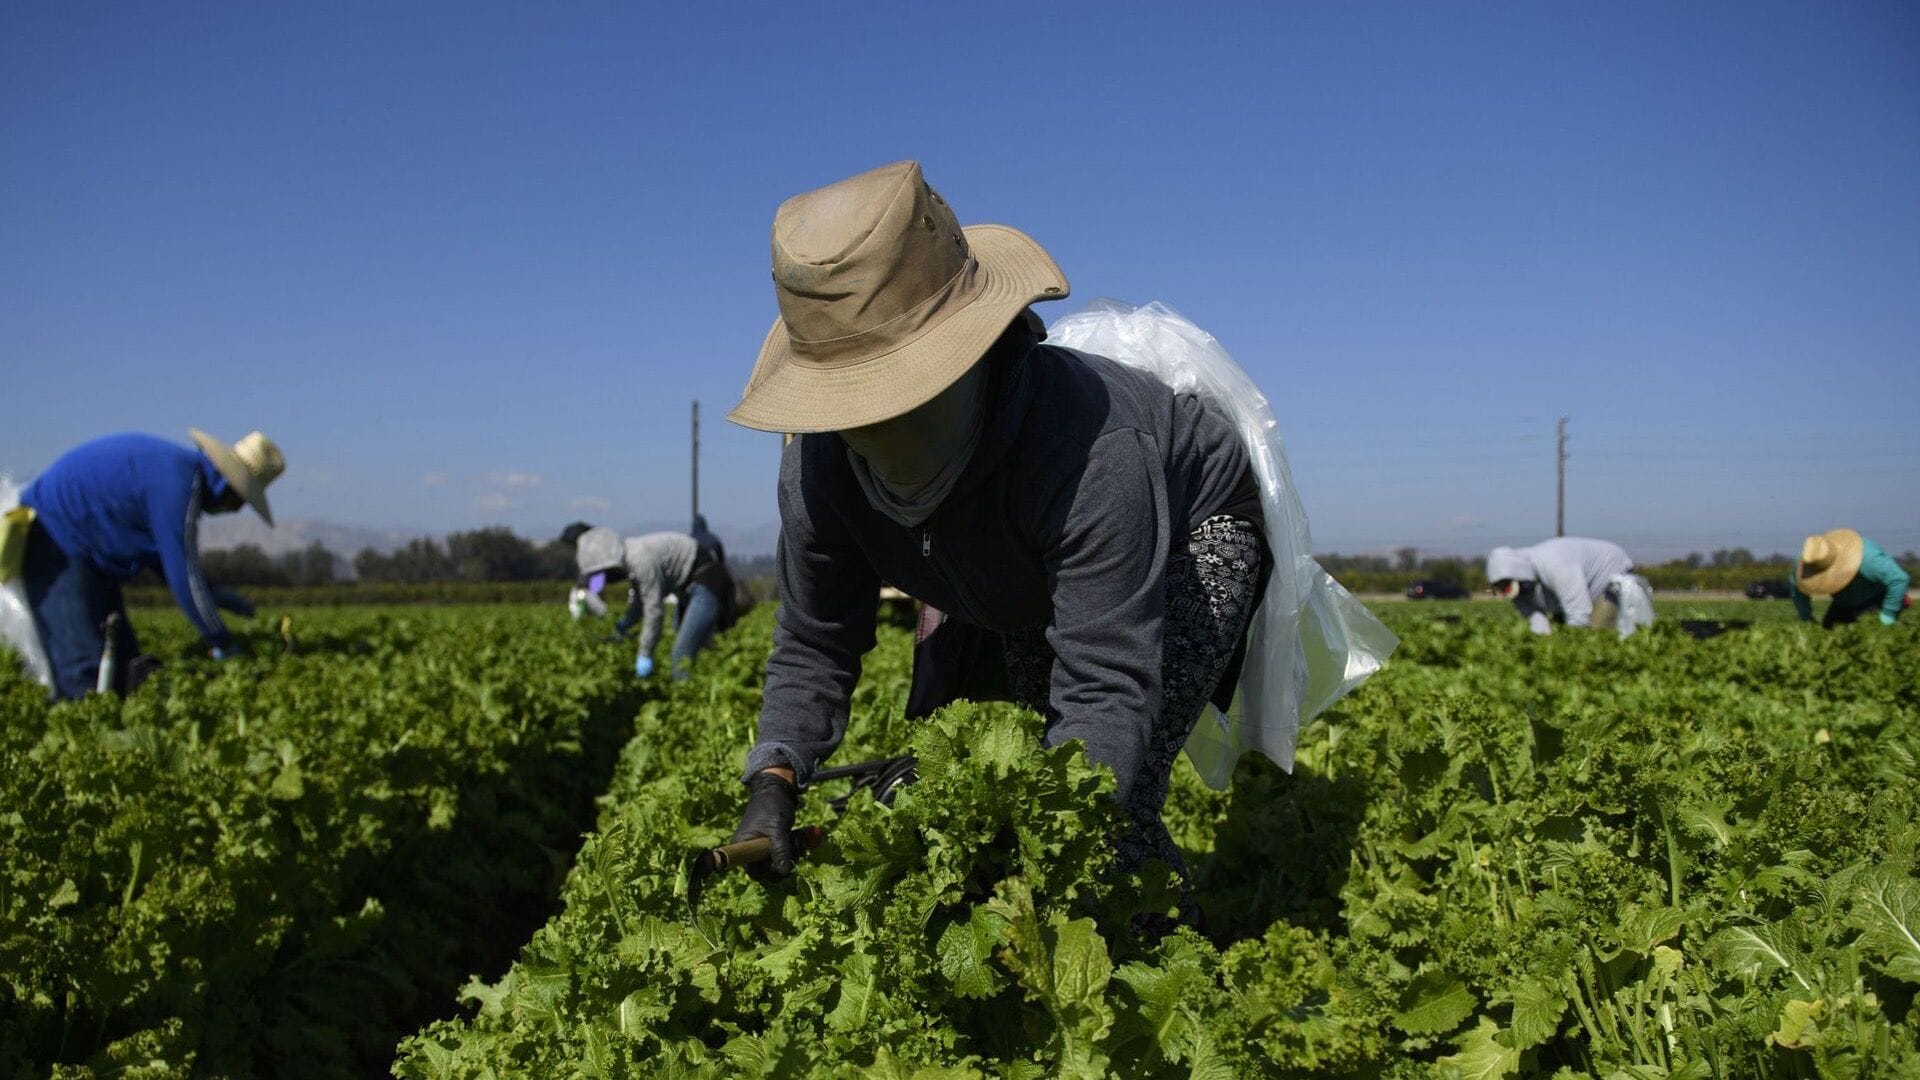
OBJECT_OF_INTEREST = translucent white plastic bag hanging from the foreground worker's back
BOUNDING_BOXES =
[1046,300,1400,790]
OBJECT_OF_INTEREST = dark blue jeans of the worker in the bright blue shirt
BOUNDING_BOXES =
[21,528,140,700]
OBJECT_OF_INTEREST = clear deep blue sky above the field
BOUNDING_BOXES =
[0,2,1920,557]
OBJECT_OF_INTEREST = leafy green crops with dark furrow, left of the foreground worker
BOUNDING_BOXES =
[0,609,641,1076]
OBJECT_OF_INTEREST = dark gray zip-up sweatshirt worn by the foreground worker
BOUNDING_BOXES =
[747,334,1260,799]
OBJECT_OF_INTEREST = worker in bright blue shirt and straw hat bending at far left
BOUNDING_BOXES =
[19,429,286,698]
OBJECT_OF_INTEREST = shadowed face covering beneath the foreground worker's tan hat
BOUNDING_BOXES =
[839,363,987,528]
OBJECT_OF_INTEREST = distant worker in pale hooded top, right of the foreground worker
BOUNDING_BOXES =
[1486,536,1653,638]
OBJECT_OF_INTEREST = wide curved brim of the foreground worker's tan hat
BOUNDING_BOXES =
[728,225,1068,434]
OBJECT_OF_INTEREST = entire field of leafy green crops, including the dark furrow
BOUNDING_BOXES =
[0,601,1920,1080]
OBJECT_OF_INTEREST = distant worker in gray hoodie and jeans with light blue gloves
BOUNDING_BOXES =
[561,523,732,678]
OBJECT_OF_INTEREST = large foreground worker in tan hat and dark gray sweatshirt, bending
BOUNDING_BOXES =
[730,161,1267,895]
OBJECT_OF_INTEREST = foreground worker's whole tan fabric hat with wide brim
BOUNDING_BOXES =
[728,161,1068,432]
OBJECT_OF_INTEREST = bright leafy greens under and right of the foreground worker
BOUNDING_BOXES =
[397,607,1920,1080]
